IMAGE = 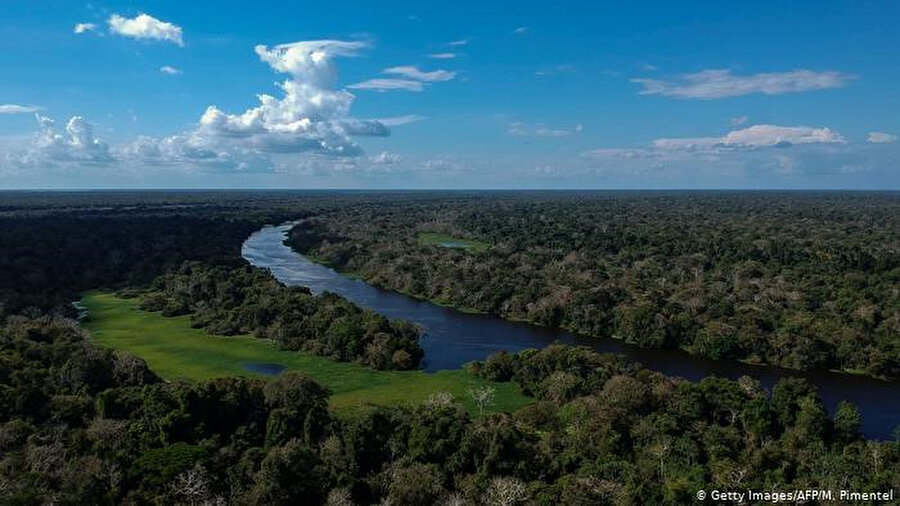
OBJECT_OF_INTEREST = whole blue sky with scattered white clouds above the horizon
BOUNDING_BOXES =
[0,1,900,189]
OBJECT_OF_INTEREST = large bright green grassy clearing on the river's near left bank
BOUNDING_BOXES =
[81,292,532,413]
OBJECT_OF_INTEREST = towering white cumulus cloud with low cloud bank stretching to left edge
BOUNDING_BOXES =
[4,40,408,176]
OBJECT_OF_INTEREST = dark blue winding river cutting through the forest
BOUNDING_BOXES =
[242,225,900,439]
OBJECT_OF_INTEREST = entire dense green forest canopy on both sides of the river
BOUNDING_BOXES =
[0,192,900,506]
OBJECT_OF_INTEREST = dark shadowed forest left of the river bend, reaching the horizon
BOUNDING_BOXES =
[0,191,362,317]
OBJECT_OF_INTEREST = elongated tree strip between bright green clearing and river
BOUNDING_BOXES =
[142,262,422,370]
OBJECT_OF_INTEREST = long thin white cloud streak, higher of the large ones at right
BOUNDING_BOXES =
[631,69,854,100]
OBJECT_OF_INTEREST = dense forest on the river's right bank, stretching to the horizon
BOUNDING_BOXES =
[291,192,900,377]
